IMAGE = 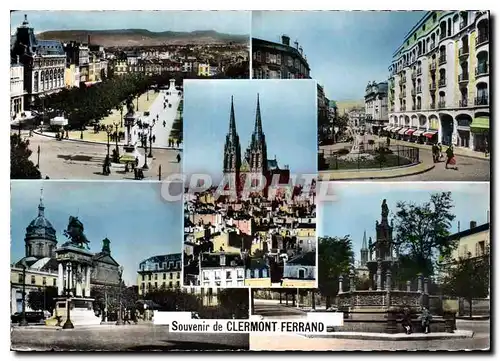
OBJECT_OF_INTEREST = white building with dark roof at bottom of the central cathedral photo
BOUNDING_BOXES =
[198,252,245,287]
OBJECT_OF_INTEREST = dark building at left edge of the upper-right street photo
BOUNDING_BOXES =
[252,35,311,79]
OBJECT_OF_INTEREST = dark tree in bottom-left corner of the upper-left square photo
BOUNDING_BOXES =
[10,134,41,179]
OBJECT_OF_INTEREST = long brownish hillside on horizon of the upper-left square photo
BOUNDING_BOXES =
[37,29,249,47]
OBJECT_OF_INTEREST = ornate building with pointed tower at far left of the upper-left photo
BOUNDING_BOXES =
[11,15,66,104]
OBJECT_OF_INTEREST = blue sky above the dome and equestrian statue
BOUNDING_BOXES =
[11,181,183,285]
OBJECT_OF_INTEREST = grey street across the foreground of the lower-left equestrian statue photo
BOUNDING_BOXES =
[11,324,249,351]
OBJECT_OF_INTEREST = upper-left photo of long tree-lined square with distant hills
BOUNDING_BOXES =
[10,11,251,181]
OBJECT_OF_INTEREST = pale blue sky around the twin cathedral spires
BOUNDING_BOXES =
[183,80,317,182]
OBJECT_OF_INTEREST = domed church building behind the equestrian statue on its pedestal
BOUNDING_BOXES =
[10,190,120,314]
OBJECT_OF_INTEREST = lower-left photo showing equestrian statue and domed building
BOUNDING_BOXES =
[10,180,249,351]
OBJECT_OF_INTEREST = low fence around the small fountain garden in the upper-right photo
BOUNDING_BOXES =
[318,143,420,170]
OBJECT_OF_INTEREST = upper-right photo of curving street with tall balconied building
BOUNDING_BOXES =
[252,10,492,182]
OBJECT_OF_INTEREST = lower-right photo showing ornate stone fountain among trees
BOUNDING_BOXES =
[250,182,491,351]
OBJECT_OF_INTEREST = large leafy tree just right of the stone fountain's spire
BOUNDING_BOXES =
[393,192,457,276]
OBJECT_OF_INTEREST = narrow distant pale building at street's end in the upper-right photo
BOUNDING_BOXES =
[365,81,389,134]
